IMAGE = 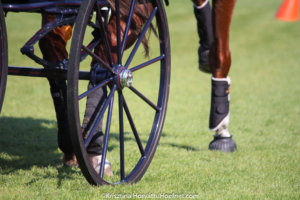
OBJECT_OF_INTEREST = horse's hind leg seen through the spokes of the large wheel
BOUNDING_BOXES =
[89,0,153,137]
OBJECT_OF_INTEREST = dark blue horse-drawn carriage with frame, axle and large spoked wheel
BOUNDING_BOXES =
[0,0,170,185]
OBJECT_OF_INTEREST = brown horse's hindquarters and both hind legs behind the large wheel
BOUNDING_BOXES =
[39,0,155,172]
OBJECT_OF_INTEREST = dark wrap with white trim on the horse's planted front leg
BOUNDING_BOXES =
[209,77,230,137]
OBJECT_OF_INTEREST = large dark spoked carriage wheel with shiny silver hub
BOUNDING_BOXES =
[68,0,170,185]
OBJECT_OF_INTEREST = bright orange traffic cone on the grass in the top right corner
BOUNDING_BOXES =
[276,0,299,21]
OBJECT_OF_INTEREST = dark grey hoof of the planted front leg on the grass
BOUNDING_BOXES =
[208,136,237,152]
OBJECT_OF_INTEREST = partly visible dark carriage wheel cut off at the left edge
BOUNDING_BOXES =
[0,2,8,112]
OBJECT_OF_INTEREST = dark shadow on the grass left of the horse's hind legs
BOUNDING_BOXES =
[0,117,79,186]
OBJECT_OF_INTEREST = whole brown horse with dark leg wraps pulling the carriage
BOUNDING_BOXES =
[40,0,236,170]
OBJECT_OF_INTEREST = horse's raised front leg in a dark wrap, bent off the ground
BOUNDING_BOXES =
[193,0,213,73]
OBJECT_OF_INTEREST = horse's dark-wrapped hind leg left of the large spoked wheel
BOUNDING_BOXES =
[39,14,77,166]
